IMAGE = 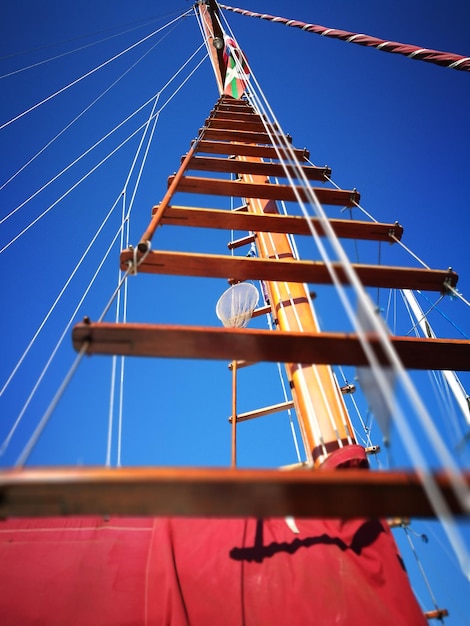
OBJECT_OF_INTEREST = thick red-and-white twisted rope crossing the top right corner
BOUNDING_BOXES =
[219,4,470,72]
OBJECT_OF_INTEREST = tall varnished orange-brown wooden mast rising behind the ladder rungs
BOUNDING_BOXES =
[196,0,366,466]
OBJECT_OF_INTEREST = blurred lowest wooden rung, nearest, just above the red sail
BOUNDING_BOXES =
[0,468,470,519]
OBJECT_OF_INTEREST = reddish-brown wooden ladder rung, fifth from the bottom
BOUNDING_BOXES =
[168,176,360,207]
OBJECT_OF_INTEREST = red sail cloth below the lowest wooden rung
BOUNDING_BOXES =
[0,517,426,626]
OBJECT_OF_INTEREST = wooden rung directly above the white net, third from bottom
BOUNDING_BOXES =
[121,250,458,292]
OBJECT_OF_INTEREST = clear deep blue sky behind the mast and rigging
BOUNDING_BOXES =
[0,0,470,625]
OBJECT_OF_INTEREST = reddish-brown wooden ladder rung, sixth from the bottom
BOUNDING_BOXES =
[187,156,331,181]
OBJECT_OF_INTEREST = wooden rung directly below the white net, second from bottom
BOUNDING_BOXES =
[72,321,470,371]
